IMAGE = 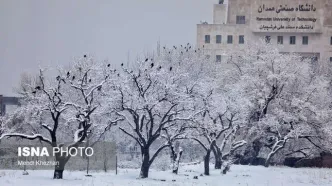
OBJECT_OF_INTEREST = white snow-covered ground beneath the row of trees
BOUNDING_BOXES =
[0,165,332,186]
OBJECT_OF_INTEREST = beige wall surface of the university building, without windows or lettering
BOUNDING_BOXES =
[197,0,332,61]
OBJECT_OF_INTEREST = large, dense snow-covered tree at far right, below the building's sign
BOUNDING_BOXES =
[225,41,326,166]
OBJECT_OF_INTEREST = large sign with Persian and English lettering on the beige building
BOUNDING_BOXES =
[251,0,323,33]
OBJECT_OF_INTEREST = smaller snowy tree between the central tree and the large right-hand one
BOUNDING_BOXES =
[191,86,250,175]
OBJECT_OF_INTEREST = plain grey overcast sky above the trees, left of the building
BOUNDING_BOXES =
[0,0,217,95]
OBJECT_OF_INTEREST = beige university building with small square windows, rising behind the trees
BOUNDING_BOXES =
[197,0,332,62]
